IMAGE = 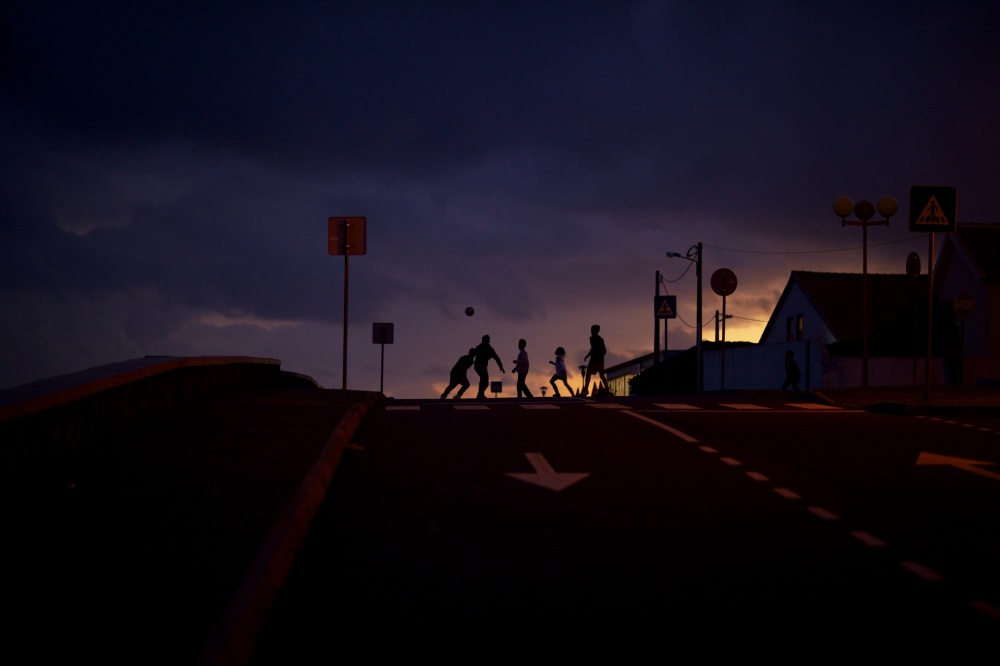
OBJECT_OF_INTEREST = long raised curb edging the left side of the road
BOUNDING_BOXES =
[198,393,384,666]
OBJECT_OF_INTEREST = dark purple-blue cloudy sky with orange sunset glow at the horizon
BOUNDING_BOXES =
[0,1,1000,397]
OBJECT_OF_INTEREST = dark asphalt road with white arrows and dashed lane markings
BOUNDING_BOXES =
[254,397,1000,664]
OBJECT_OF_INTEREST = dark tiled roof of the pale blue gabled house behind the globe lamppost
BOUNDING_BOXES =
[761,271,927,342]
